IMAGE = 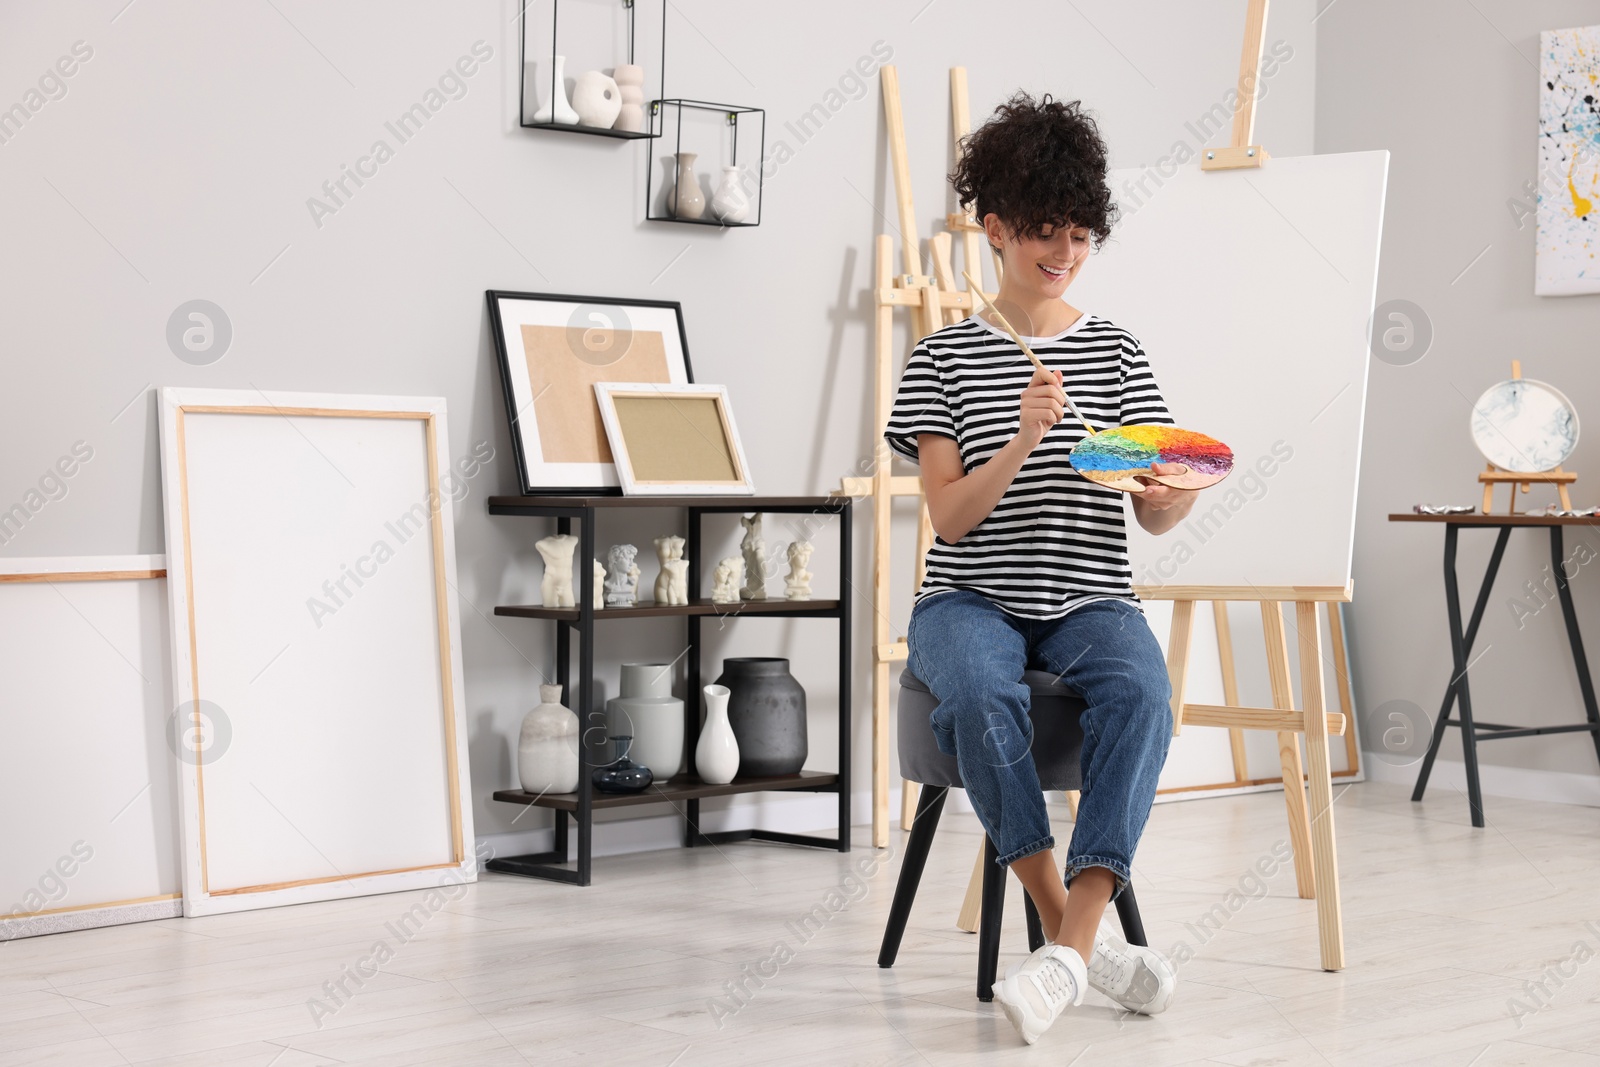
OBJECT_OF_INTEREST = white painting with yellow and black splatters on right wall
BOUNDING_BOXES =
[1533,26,1600,296]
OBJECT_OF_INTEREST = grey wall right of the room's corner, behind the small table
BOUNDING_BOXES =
[1317,0,1600,783]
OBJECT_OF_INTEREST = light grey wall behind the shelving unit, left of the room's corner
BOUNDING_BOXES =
[0,0,1318,848]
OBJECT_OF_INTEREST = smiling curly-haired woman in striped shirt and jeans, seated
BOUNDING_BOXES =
[885,93,1195,1045]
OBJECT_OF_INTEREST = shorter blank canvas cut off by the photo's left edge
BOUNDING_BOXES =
[0,555,182,941]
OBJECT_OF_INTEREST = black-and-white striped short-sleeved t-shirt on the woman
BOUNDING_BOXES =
[883,312,1173,619]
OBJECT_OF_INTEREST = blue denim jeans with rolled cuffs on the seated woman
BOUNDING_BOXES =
[907,589,1173,893]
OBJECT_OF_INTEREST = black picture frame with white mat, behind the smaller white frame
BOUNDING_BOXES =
[485,290,694,496]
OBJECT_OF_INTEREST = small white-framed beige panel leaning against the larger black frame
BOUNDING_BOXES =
[594,382,755,496]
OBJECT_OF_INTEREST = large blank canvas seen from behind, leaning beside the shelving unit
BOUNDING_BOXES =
[162,389,475,915]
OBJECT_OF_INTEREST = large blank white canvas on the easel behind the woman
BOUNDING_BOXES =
[1072,152,1389,789]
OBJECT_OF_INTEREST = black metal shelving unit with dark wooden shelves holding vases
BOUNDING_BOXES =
[486,494,854,886]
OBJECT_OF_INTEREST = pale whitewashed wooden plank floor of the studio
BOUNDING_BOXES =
[0,784,1600,1067]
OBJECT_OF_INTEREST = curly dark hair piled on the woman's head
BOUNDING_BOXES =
[950,93,1117,248]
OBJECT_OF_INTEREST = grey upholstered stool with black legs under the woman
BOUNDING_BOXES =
[878,667,1149,1001]
